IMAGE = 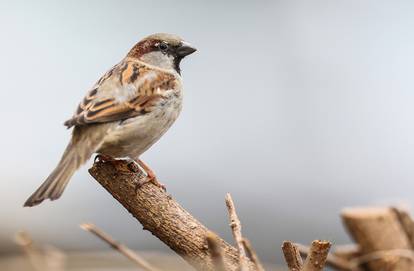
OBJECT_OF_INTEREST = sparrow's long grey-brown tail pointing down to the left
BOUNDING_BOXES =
[24,125,111,207]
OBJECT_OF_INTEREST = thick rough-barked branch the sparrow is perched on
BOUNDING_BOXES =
[89,161,256,271]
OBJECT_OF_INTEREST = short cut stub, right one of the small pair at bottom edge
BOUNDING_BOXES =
[302,240,331,271]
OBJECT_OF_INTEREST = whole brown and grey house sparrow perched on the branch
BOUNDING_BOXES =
[24,34,196,206]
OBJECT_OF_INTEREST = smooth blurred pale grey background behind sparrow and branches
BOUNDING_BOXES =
[0,0,414,261]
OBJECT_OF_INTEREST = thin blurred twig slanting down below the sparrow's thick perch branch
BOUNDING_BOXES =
[80,223,158,271]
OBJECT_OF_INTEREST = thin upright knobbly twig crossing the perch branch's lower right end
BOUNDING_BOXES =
[226,193,248,271]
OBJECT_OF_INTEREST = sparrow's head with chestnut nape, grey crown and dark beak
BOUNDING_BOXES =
[127,33,196,73]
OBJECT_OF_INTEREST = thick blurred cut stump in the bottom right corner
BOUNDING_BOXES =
[342,208,414,271]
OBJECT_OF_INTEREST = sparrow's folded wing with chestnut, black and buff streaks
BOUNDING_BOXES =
[65,59,179,128]
